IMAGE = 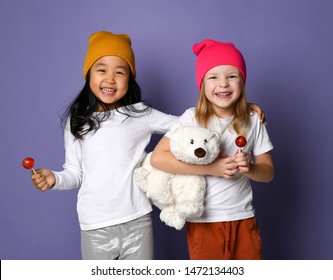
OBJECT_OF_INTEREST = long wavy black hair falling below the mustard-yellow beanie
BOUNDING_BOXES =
[62,71,151,139]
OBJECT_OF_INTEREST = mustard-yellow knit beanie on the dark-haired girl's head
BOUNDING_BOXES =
[83,31,136,79]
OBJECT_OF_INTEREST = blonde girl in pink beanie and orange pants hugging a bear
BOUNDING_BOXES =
[151,39,274,259]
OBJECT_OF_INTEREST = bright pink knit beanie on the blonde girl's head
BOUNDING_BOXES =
[192,39,246,91]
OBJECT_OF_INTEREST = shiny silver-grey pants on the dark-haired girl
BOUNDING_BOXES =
[81,214,154,260]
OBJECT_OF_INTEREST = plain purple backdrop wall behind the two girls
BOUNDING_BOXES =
[0,0,333,259]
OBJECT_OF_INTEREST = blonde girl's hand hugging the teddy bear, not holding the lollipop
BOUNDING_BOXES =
[210,155,238,179]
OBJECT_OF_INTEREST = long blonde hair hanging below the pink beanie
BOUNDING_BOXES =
[195,79,250,135]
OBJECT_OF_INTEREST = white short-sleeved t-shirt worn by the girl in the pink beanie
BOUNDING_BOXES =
[166,108,273,222]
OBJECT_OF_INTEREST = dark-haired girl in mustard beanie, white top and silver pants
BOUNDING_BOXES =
[32,31,176,259]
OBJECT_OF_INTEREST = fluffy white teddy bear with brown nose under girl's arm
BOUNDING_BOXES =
[134,124,220,230]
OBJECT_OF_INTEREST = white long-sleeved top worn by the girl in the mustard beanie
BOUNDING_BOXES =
[53,103,177,230]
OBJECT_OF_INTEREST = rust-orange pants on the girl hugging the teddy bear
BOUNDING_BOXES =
[187,217,262,260]
